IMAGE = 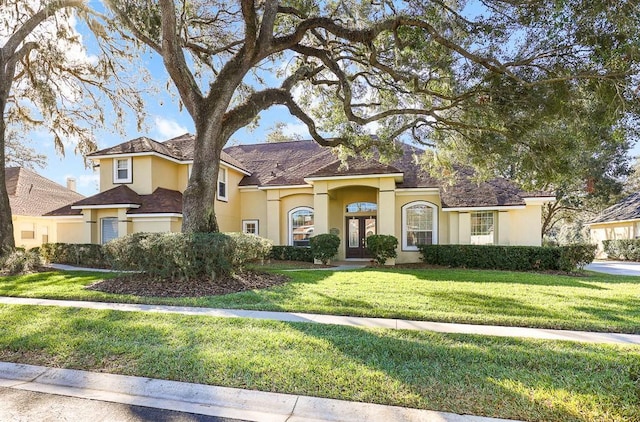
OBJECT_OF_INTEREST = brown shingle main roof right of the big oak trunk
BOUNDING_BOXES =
[225,141,553,208]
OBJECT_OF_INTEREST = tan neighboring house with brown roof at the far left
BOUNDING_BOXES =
[4,167,84,248]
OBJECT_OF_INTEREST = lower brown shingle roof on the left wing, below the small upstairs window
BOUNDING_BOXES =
[47,185,182,216]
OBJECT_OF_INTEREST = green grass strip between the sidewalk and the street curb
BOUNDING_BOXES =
[0,305,640,421]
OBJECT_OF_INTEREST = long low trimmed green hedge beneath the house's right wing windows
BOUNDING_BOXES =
[418,244,596,272]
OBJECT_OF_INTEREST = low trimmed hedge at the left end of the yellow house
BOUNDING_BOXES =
[40,243,108,268]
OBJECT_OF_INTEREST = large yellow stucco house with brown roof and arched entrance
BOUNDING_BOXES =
[49,134,555,262]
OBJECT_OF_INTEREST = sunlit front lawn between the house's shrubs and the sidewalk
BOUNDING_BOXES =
[0,269,640,333]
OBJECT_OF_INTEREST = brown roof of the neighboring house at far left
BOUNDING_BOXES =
[5,167,84,216]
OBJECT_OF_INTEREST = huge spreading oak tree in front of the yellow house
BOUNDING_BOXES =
[107,0,639,232]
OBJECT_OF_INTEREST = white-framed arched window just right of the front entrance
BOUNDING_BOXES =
[402,201,438,251]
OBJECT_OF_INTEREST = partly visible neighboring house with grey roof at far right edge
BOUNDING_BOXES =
[588,192,640,257]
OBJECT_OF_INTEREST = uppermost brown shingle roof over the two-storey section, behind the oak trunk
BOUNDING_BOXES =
[87,133,249,173]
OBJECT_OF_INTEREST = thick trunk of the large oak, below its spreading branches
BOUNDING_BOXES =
[182,118,225,233]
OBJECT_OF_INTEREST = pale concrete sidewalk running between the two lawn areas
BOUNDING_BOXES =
[0,296,640,344]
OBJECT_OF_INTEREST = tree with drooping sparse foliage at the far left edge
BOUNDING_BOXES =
[0,0,142,255]
